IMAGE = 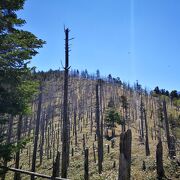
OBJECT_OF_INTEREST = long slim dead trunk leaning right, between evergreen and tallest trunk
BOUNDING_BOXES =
[31,82,42,180]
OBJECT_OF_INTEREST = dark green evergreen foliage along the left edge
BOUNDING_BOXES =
[0,0,45,169]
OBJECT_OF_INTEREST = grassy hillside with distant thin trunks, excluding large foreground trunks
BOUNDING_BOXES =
[6,71,180,180]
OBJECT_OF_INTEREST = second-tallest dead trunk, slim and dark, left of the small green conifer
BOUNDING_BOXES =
[96,83,102,174]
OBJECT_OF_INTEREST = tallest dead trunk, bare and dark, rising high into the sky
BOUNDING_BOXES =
[61,28,70,178]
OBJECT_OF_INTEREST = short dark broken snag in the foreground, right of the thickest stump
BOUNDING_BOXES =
[156,140,165,180]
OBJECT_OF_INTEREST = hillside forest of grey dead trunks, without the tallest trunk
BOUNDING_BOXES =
[1,66,180,179]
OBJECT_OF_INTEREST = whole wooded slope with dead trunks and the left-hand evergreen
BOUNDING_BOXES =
[0,0,180,180]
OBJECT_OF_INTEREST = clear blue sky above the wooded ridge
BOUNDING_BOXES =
[19,0,180,90]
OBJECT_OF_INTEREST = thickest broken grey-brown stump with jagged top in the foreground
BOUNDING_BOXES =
[118,129,132,180]
